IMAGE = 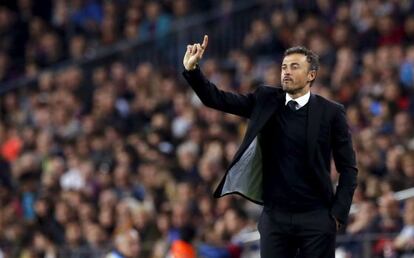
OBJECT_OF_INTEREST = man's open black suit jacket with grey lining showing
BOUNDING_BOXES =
[183,68,358,223]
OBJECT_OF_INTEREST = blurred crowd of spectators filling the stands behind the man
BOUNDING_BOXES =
[0,0,414,258]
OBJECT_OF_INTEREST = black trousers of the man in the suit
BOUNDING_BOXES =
[258,206,336,258]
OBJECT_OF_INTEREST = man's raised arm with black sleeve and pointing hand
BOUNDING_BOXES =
[183,35,255,118]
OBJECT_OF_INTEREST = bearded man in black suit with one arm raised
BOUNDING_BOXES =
[183,36,357,258]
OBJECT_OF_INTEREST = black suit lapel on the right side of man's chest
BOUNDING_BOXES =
[306,94,323,164]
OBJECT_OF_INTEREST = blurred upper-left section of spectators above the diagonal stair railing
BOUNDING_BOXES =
[0,0,217,82]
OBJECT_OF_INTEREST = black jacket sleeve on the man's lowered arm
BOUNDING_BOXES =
[331,105,358,224]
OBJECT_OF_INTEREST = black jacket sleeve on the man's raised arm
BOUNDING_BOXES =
[183,67,255,118]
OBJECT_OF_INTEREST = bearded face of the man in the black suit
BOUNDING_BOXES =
[281,53,316,96]
